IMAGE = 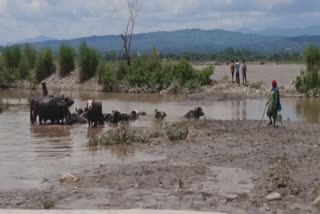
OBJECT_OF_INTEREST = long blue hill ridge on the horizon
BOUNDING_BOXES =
[9,29,320,54]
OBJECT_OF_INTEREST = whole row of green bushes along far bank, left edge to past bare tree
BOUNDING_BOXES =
[0,43,213,90]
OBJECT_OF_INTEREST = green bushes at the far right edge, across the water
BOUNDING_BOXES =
[296,45,320,96]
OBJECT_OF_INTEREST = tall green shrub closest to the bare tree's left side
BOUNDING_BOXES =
[79,42,99,82]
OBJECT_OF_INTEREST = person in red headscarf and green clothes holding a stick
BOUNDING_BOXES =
[267,80,282,127]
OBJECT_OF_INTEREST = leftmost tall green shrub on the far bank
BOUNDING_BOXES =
[2,46,21,70]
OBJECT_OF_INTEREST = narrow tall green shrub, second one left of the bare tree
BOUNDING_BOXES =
[58,45,75,76]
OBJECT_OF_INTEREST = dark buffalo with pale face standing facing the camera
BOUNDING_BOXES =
[87,100,104,127]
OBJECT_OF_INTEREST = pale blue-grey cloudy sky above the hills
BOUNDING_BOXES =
[0,0,320,43]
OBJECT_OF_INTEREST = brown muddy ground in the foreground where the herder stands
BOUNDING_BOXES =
[0,121,320,214]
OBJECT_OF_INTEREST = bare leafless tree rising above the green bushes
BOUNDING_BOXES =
[121,0,139,66]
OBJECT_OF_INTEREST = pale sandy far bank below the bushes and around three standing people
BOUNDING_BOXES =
[0,63,305,99]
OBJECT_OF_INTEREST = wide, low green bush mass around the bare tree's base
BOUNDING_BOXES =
[98,52,213,90]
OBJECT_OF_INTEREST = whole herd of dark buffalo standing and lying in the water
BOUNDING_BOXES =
[30,95,204,127]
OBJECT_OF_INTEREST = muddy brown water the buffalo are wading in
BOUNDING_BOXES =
[0,90,320,190]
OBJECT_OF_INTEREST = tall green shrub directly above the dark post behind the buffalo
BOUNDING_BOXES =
[35,49,55,82]
